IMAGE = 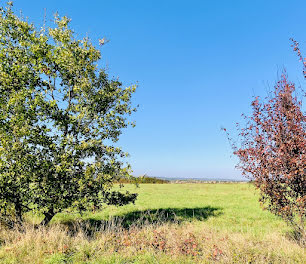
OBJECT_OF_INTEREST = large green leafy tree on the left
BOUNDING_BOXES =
[0,3,136,224]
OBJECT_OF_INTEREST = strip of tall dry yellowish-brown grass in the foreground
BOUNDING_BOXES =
[0,219,306,264]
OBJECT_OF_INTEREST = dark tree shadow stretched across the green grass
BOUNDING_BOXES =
[62,206,222,236]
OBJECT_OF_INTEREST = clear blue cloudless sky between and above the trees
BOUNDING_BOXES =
[8,0,306,179]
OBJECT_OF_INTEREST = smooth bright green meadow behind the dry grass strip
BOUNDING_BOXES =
[53,183,290,236]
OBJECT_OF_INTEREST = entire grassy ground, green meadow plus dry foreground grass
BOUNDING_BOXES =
[0,183,306,263]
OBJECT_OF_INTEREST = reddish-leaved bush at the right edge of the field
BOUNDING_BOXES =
[226,68,306,241]
